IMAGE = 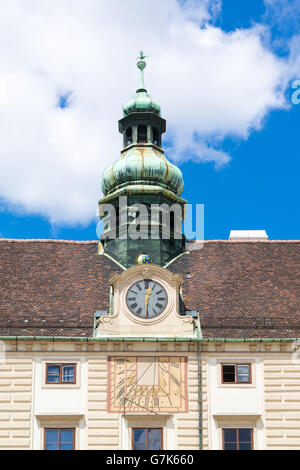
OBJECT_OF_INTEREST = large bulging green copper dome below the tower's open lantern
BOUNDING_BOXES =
[102,144,183,196]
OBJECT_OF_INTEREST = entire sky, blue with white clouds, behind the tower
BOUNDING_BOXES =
[0,0,300,240]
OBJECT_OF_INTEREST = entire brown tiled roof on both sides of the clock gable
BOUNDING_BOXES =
[0,239,300,338]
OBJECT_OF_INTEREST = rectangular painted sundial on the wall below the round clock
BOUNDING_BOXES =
[107,356,188,414]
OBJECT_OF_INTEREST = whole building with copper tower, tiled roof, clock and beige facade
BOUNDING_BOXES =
[0,53,300,450]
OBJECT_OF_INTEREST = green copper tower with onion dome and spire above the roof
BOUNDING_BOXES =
[99,51,186,268]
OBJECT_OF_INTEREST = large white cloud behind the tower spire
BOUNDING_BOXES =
[0,0,297,224]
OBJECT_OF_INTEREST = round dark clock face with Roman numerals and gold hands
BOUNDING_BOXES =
[126,279,168,319]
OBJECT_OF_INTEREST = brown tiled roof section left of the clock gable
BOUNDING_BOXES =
[0,240,120,337]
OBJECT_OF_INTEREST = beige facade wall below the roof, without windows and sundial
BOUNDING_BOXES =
[0,341,300,450]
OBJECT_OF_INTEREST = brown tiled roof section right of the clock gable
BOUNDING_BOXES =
[170,241,300,338]
